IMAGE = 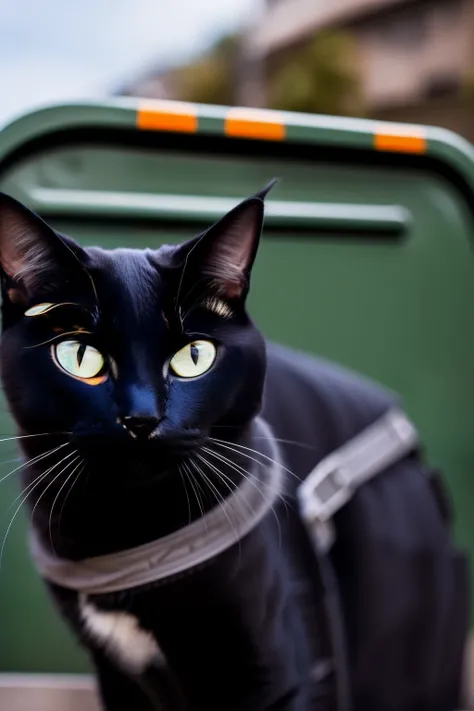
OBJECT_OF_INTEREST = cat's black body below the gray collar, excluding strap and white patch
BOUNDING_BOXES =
[48,345,469,711]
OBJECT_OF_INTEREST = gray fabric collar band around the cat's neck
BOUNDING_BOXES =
[30,421,283,595]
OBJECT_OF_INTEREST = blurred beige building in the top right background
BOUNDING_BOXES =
[247,0,474,138]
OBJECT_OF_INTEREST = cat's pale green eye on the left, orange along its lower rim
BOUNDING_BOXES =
[52,341,107,385]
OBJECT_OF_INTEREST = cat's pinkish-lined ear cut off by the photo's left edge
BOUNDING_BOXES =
[0,193,85,299]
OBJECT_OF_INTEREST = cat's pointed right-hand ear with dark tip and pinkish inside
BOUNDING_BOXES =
[179,180,277,299]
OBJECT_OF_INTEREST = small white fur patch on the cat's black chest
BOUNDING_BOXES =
[79,596,161,674]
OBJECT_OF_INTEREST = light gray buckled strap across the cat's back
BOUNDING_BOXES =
[298,408,418,550]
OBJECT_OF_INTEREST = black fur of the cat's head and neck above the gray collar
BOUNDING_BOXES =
[0,192,265,558]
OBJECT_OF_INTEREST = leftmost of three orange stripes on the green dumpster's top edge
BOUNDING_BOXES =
[137,101,198,133]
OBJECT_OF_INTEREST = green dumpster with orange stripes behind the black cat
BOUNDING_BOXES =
[0,101,474,672]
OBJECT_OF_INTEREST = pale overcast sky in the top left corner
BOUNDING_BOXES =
[0,0,260,124]
